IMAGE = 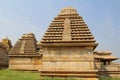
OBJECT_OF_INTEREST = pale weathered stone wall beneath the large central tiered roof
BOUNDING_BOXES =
[42,47,94,71]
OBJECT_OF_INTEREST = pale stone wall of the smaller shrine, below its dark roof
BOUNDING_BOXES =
[9,56,41,71]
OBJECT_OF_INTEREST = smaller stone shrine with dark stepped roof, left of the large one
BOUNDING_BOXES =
[9,33,41,70]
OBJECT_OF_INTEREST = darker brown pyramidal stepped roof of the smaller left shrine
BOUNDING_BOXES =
[9,33,37,55]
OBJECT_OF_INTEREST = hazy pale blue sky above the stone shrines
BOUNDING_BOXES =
[0,0,120,62]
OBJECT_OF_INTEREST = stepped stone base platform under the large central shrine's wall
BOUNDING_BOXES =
[39,70,98,80]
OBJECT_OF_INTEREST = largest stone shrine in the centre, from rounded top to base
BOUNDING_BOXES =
[39,7,98,80]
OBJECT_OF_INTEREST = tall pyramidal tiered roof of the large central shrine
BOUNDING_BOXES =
[41,7,98,47]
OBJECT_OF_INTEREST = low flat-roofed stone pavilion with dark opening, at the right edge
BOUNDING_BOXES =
[93,51,120,77]
